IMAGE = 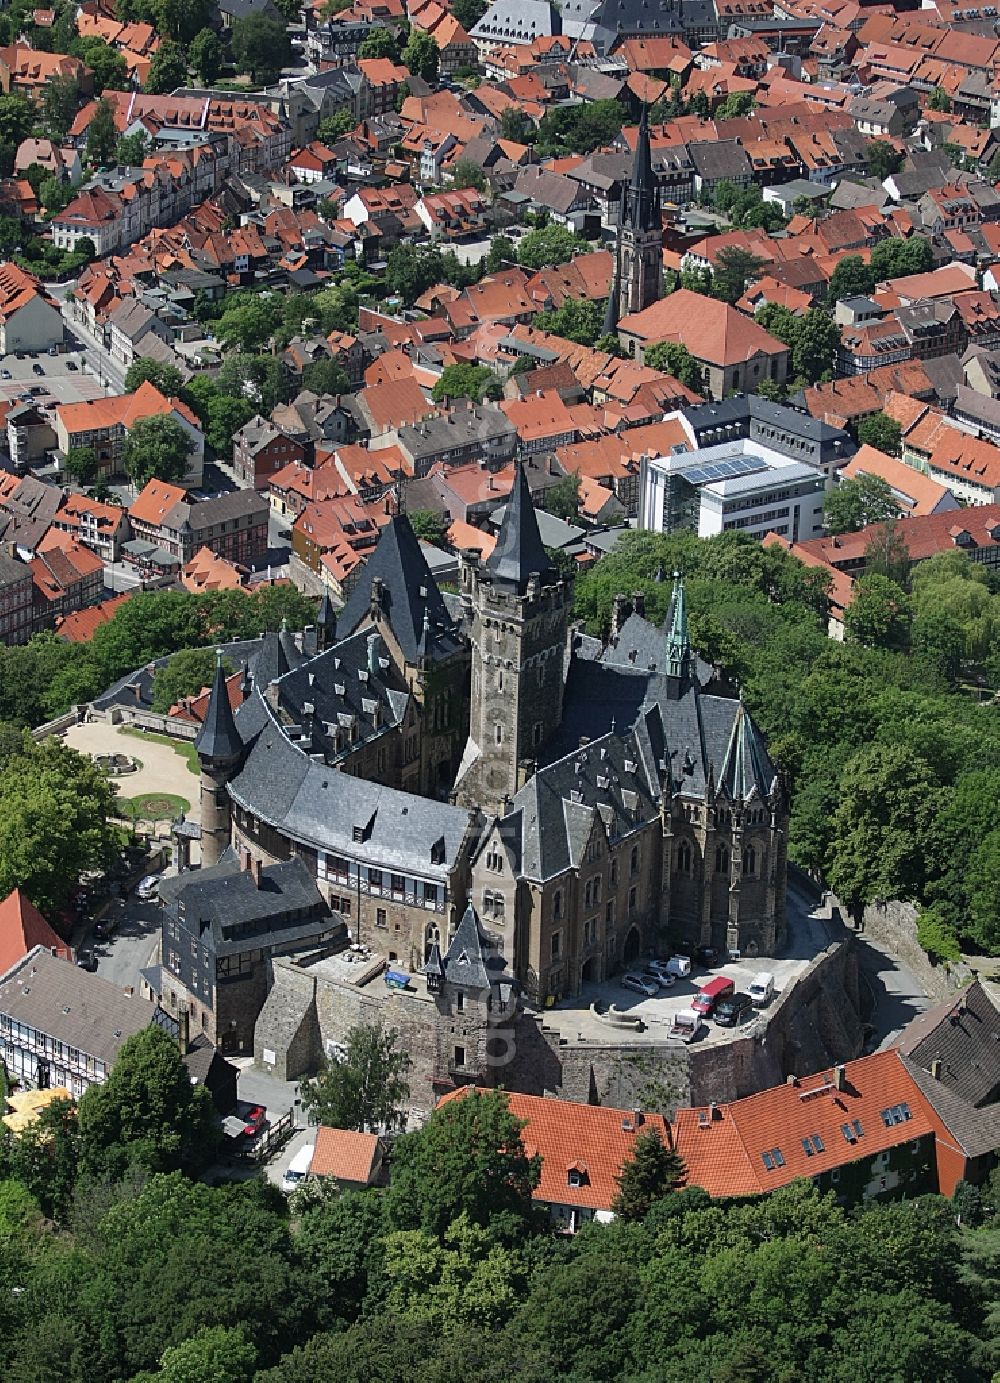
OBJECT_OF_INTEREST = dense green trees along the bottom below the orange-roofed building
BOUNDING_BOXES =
[0,1028,1000,1383]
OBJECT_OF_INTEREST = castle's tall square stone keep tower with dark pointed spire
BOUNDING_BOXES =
[454,466,573,815]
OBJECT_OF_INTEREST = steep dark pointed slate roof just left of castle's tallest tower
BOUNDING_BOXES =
[337,514,459,664]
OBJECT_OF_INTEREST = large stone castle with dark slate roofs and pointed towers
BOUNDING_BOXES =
[196,469,787,1007]
